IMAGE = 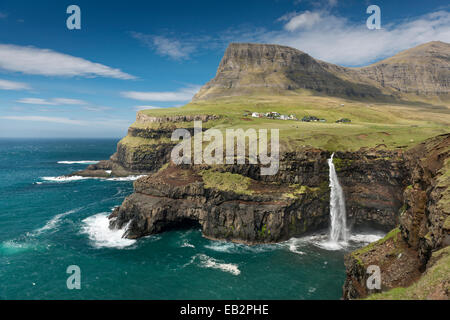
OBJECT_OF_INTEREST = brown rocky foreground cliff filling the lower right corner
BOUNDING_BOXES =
[344,134,450,299]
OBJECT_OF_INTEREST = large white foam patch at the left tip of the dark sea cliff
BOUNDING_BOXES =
[82,213,136,249]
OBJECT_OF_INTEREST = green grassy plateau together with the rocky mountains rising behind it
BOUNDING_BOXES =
[123,41,450,151]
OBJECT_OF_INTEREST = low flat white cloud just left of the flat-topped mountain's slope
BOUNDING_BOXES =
[121,86,201,101]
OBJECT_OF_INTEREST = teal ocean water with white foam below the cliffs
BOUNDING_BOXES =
[0,139,382,299]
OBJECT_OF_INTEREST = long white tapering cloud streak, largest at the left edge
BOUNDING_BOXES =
[0,44,135,79]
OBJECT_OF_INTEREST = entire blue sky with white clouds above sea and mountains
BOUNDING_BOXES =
[0,0,450,137]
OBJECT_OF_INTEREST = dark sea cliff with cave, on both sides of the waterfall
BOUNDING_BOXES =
[111,122,408,244]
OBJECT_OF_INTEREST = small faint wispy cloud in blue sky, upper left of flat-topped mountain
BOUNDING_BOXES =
[131,32,195,60]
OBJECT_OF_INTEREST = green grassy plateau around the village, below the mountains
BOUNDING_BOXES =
[132,92,450,151]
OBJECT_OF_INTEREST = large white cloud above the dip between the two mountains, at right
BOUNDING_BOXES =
[266,11,450,66]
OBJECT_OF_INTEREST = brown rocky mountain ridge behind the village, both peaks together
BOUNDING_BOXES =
[194,42,450,101]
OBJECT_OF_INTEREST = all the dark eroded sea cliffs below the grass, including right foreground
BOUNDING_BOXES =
[75,109,450,299]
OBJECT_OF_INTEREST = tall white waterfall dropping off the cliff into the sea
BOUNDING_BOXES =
[328,153,347,244]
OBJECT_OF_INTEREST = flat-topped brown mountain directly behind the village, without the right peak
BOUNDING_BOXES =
[193,43,382,101]
